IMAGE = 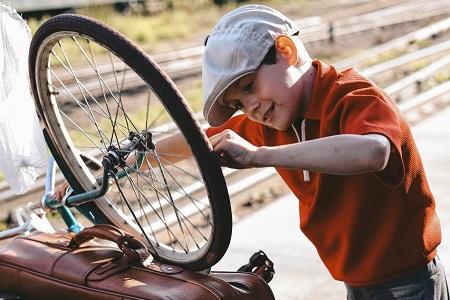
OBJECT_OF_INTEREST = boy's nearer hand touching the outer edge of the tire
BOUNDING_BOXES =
[210,129,258,169]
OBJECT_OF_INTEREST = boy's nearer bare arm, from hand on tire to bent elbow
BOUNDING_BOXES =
[210,130,391,175]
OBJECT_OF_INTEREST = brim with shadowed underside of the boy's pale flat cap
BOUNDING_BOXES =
[206,70,255,127]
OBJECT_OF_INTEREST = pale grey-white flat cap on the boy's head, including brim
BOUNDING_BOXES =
[202,5,299,126]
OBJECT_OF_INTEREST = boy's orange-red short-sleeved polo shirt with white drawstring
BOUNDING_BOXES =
[207,61,441,286]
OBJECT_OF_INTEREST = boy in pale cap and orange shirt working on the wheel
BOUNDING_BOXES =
[203,5,448,299]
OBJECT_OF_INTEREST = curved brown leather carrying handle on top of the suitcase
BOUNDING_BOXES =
[69,224,150,265]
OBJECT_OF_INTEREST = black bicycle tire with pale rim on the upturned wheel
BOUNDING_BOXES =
[29,14,232,270]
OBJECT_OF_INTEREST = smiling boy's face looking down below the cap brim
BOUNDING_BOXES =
[219,58,301,130]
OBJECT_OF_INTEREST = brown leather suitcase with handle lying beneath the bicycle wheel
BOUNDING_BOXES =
[0,225,274,300]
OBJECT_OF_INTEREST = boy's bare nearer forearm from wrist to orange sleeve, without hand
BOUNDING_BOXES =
[253,134,390,175]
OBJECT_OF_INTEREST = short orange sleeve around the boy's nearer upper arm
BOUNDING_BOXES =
[338,88,405,187]
